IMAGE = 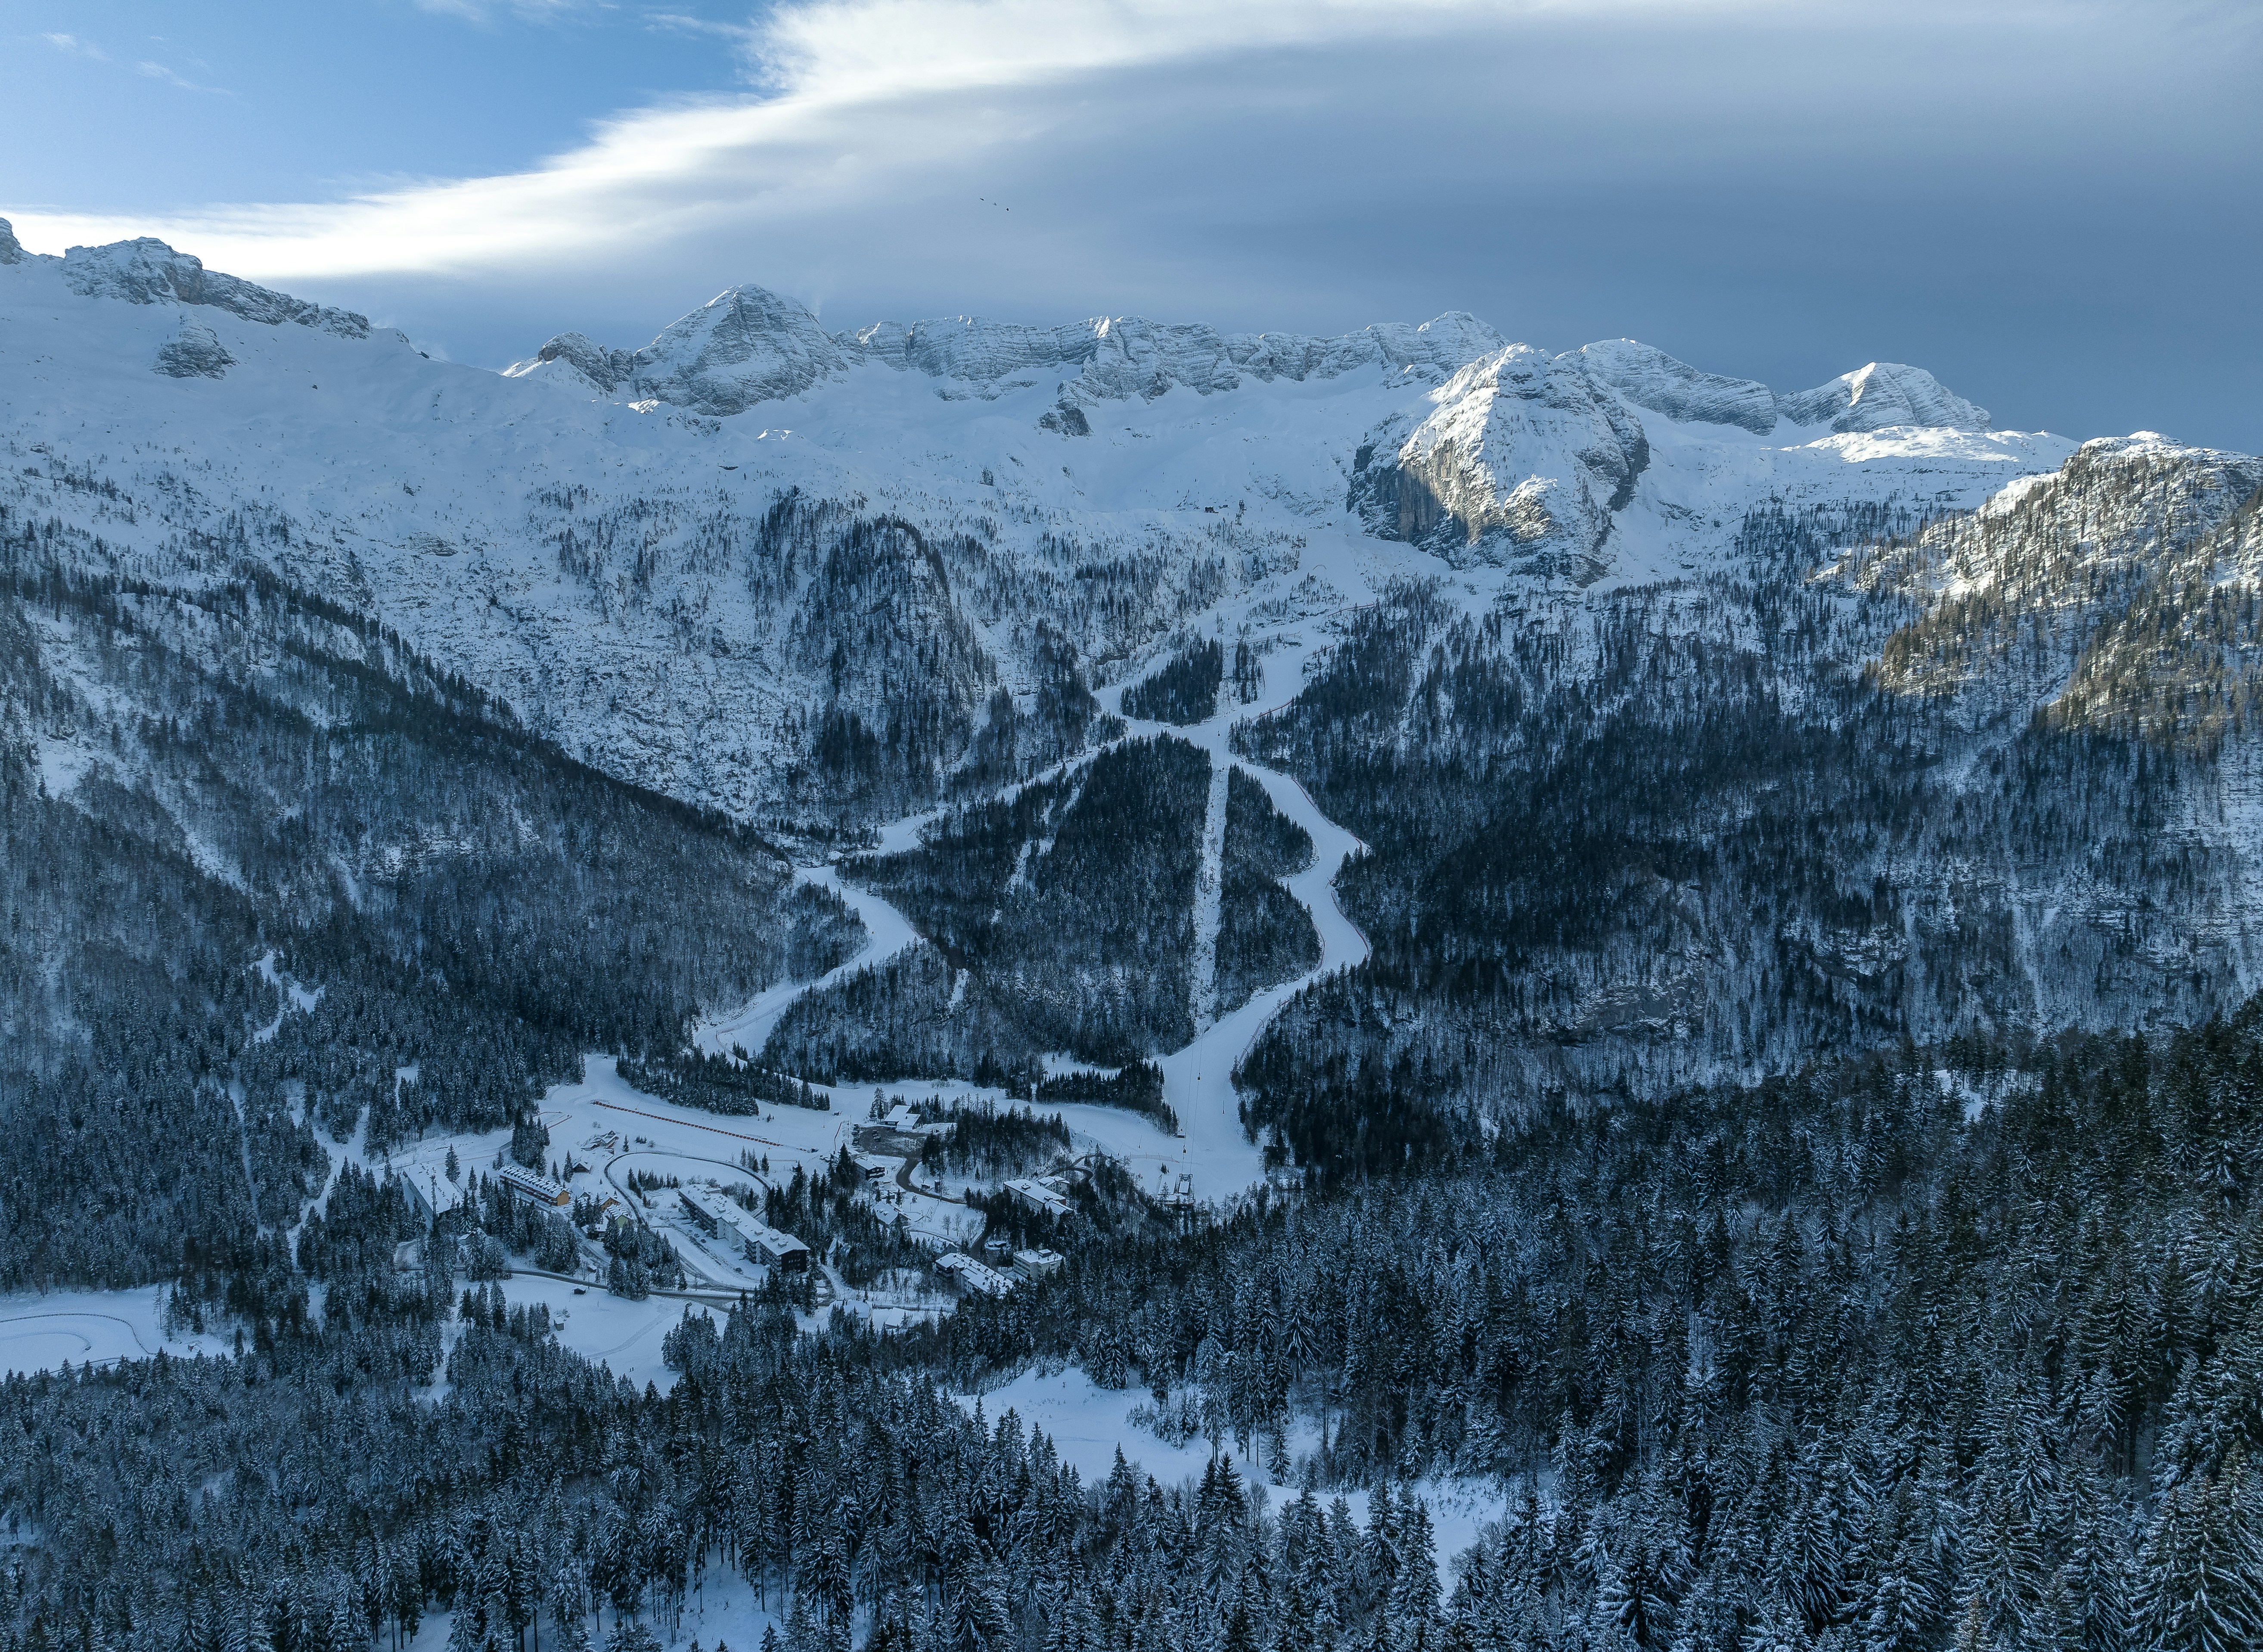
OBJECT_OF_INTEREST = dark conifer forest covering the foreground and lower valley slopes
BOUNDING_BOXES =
[13,475,2263,1652]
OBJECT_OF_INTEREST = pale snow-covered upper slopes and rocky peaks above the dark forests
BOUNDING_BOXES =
[0,220,2071,819]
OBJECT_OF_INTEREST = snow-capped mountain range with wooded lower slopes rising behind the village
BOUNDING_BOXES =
[0,212,2263,1152]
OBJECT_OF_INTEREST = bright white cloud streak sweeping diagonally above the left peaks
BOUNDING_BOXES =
[4,0,1781,281]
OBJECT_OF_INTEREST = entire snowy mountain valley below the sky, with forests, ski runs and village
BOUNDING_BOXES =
[0,222,2263,1652]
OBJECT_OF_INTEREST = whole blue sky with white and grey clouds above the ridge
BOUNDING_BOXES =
[0,0,2263,450]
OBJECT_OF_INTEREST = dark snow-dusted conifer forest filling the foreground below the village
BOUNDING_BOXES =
[13,1005,2263,1650]
